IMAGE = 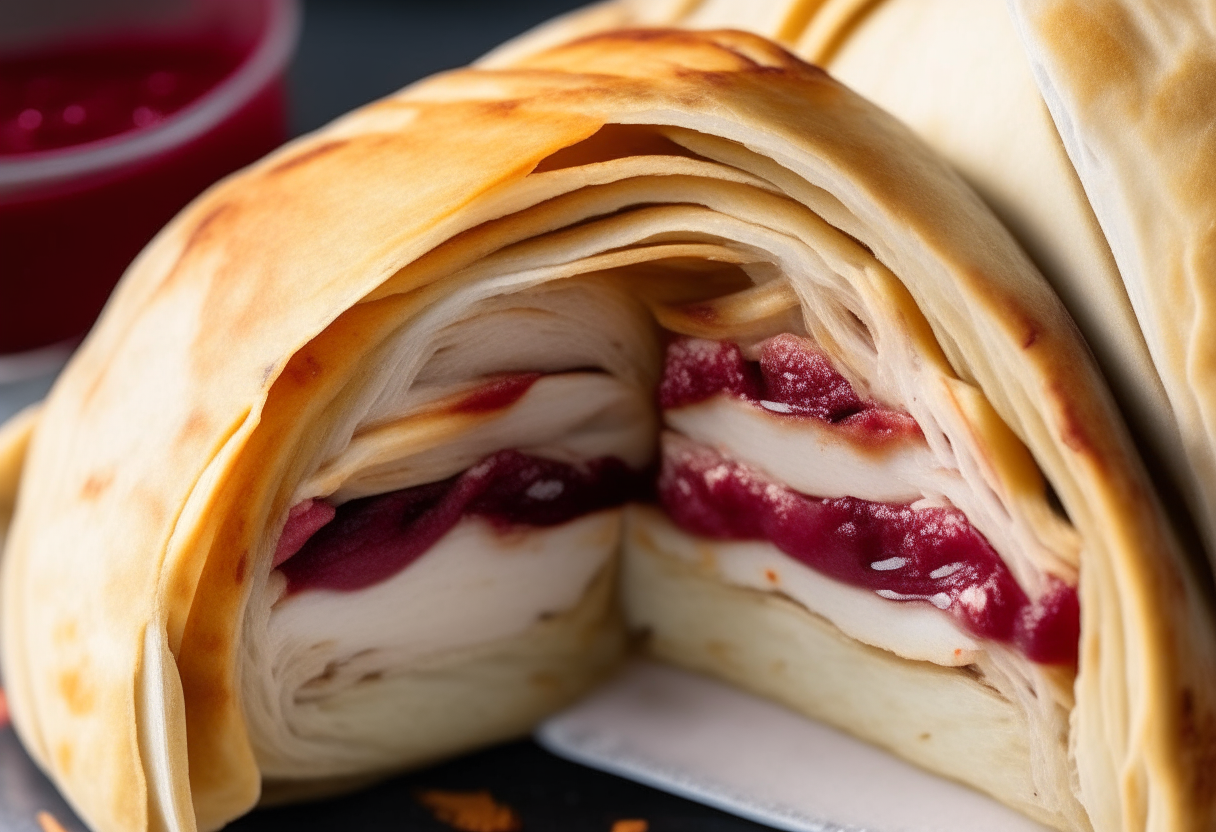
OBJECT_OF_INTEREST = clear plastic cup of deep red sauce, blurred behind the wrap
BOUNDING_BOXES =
[0,0,299,369]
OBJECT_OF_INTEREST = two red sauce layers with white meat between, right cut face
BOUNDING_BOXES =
[658,335,1080,664]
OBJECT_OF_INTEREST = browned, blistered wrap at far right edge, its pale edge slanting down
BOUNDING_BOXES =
[1009,0,1216,578]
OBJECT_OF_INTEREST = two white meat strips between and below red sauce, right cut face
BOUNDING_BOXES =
[663,369,1065,667]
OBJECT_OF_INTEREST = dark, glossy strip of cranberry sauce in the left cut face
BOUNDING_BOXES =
[276,450,654,592]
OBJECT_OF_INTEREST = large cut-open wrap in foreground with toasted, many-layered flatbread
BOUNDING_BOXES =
[2,32,1216,831]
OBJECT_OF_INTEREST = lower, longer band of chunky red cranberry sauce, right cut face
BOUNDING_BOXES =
[659,440,1080,664]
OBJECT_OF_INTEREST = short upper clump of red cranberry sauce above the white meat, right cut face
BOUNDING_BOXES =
[659,335,922,442]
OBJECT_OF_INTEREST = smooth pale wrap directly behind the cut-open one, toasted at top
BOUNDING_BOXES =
[483,0,1186,558]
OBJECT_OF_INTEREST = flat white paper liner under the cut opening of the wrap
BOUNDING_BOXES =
[536,660,1048,832]
